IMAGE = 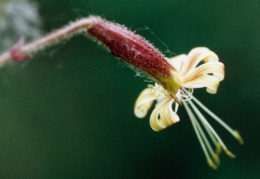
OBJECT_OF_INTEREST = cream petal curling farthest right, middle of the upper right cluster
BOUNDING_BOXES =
[183,62,225,83]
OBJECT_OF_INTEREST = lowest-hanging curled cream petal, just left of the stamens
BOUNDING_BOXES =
[150,97,180,131]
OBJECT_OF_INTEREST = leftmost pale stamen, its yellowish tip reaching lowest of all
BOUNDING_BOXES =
[183,102,217,169]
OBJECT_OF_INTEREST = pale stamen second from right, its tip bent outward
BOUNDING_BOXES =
[188,101,235,158]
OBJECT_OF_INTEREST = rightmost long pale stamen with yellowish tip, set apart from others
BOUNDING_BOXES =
[192,96,244,145]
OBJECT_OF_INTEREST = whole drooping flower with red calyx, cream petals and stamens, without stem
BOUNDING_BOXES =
[87,17,243,169]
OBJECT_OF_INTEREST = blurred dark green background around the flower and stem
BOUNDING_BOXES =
[0,0,260,179]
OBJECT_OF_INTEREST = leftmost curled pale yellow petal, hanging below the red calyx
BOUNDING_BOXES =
[134,88,158,118]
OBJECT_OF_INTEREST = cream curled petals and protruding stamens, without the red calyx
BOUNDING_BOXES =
[134,47,243,169]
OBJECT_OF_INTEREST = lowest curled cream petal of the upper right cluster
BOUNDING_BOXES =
[183,74,219,94]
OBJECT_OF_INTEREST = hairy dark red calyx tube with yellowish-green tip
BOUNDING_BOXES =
[87,16,180,103]
